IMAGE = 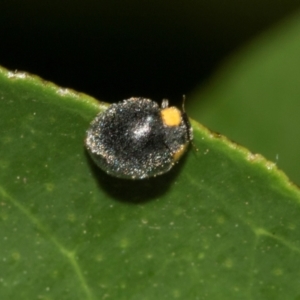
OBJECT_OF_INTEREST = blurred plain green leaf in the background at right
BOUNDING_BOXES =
[187,11,300,184]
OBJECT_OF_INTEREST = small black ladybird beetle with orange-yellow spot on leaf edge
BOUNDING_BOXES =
[85,98,193,179]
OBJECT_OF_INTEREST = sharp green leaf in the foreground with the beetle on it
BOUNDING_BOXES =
[0,63,300,300]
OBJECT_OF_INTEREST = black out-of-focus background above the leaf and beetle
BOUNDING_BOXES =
[0,0,300,102]
